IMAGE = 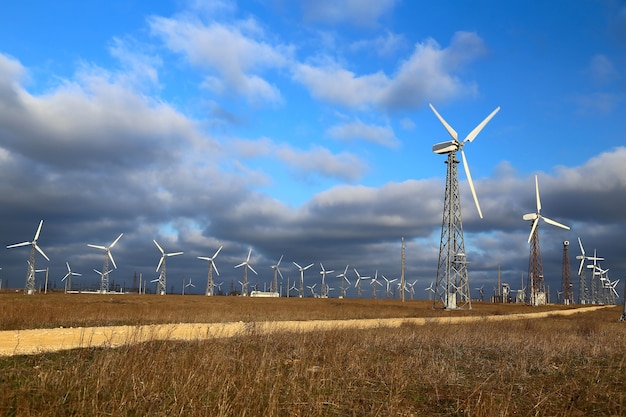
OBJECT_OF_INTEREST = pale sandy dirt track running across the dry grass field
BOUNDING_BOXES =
[0,306,604,356]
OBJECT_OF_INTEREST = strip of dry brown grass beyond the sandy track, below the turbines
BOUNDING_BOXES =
[0,293,572,330]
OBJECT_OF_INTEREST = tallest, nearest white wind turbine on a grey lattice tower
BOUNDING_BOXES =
[430,104,500,309]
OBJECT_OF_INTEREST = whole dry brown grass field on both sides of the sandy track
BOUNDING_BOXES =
[0,294,626,416]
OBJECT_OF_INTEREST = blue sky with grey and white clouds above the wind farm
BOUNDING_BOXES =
[0,0,626,299]
